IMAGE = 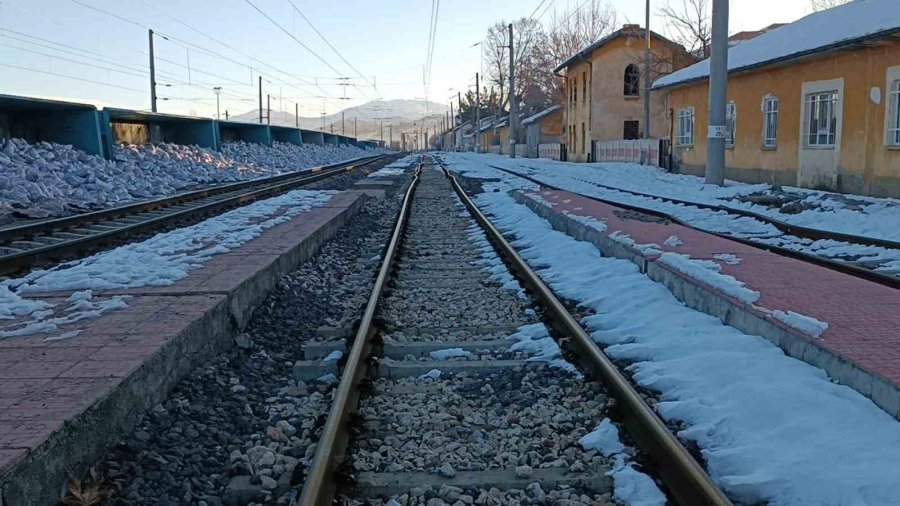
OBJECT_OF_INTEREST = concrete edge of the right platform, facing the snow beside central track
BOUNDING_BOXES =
[512,190,900,419]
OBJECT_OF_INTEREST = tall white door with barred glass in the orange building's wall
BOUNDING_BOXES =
[797,79,844,190]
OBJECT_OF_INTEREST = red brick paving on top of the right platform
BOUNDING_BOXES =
[531,190,900,385]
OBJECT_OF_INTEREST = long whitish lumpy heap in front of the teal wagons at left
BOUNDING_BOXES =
[0,139,372,224]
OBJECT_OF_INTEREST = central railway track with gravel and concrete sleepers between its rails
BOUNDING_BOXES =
[299,156,730,506]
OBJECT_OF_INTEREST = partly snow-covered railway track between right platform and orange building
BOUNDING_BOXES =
[490,165,900,288]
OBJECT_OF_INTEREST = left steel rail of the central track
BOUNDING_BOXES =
[299,157,422,506]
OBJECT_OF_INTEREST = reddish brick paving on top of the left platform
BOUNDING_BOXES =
[0,193,366,473]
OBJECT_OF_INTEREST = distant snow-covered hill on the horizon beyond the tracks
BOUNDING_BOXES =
[230,100,449,146]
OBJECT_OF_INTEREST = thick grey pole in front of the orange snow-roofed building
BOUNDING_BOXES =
[706,0,728,186]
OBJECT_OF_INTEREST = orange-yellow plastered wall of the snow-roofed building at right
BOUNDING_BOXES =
[659,42,900,196]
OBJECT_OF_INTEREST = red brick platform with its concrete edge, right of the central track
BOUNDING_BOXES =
[516,190,900,418]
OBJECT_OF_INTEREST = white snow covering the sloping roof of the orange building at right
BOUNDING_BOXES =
[653,0,900,89]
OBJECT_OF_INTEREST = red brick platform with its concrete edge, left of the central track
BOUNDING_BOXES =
[0,191,365,506]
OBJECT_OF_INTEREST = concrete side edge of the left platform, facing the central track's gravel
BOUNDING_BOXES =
[0,191,367,506]
